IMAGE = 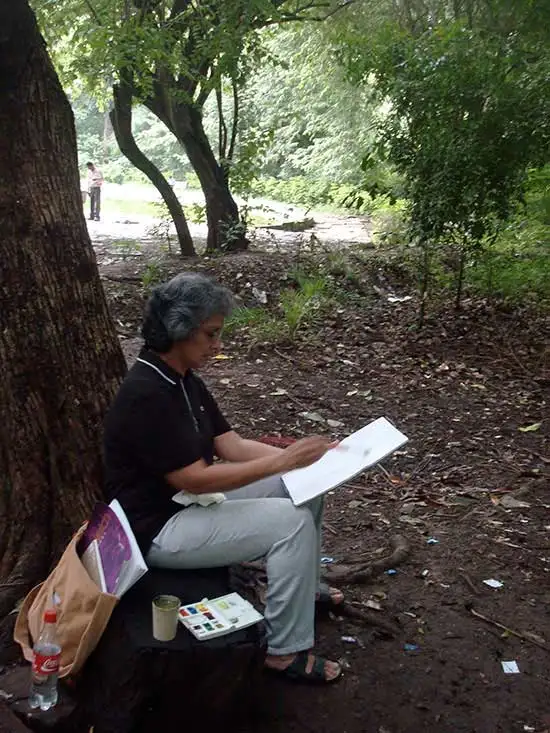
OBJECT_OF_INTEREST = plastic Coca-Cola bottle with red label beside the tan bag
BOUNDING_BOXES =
[29,610,61,710]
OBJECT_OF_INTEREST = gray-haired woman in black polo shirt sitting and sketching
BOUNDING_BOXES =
[105,273,342,682]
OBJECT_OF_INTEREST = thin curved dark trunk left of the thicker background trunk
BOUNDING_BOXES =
[111,84,196,257]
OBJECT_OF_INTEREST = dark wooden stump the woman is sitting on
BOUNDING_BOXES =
[1,568,266,733]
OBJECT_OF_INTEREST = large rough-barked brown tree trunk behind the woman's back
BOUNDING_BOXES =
[0,0,125,632]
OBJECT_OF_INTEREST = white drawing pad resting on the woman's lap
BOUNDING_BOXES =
[282,417,408,506]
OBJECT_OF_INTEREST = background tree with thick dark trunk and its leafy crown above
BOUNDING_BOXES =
[35,0,352,250]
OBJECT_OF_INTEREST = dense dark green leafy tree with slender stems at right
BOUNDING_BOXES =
[343,0,550,321]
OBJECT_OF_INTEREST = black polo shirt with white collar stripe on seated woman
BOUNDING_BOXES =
[104,349,231,554]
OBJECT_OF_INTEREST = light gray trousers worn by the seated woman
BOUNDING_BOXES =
[146,476,323,654]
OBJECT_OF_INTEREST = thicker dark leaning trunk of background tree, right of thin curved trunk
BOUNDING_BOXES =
[145,94,249,252]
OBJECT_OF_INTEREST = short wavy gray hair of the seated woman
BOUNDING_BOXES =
[141,272,234,354]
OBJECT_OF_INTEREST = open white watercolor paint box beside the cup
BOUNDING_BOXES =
[178,593,263,641]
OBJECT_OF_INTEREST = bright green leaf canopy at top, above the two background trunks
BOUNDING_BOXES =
[33,0,345,107]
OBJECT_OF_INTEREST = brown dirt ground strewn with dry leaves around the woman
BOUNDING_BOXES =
[96,223,550,733]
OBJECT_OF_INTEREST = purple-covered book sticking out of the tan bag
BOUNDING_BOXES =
[77,499,147,598]
